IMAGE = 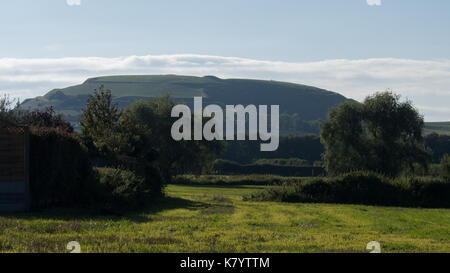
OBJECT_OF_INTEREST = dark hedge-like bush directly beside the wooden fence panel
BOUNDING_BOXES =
[30,127,97,209]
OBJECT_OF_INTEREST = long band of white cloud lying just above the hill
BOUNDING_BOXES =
[0,54,450,120]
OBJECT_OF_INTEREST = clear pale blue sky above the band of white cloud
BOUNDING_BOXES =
[0,0,450,61]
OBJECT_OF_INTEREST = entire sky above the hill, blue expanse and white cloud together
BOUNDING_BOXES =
[0,0,450,121]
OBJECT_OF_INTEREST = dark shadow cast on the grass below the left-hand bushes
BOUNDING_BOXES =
[0,197,208,223]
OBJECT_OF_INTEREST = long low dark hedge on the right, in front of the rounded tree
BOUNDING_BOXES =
[245,172,450,208]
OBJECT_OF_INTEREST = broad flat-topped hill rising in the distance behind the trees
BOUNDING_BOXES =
[22,75,347,131]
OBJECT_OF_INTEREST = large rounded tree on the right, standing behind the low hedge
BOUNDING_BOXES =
[321,92,430,176]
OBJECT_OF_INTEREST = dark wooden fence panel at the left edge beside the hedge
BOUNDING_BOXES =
[0,127,30,211]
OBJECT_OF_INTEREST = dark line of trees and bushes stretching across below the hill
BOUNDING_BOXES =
[0,89,450,207]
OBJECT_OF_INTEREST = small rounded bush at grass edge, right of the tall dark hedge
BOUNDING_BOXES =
[98,168,152,210]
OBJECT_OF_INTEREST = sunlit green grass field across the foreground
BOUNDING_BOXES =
[0,185,450,252]
